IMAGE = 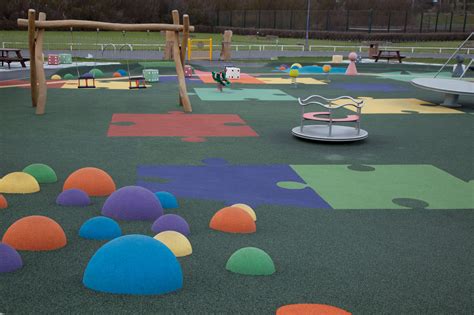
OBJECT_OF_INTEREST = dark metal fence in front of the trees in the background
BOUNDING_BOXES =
[215,10,474,33]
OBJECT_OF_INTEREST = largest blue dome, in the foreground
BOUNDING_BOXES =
[82,234,183,295]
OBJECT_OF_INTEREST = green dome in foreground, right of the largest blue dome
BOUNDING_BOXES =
[225,247,275,276]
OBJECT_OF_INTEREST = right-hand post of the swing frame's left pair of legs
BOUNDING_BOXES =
[35,12,48,115]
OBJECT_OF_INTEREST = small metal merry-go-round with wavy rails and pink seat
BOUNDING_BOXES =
[291,95,369,142]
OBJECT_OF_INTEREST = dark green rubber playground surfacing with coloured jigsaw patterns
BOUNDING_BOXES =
[0,61,474,314]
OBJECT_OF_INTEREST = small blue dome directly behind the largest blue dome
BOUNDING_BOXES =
[79,216,122,241]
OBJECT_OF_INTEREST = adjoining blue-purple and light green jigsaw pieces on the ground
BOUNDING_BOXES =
[137,159,474,209]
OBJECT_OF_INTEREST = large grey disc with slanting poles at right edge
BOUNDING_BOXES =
[411,32,474,107]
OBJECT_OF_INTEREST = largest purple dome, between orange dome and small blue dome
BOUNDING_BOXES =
[102,186,163,221]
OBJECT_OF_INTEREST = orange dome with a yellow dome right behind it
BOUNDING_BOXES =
[209,207,257,233]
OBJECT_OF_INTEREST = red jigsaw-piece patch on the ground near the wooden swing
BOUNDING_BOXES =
[107,112,258,142]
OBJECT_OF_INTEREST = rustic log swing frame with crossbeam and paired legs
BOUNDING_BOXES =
[17,9,194,115]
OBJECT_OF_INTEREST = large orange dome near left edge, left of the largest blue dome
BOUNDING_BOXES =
[2,215,67,251]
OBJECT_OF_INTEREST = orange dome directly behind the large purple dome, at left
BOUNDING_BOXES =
[63,167,115,197]
